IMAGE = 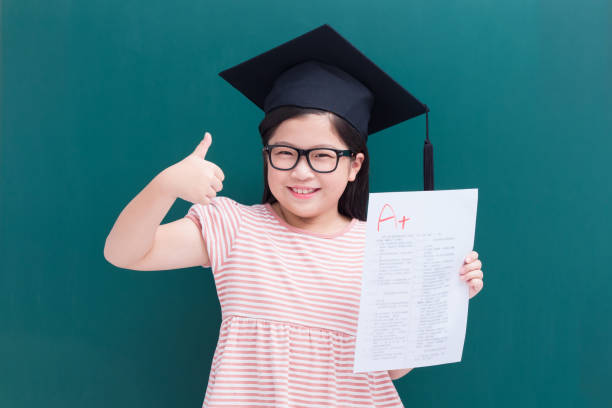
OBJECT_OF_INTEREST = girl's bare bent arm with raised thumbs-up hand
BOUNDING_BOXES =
[104,132,225,271]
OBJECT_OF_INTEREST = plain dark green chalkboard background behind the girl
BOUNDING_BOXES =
[0,0,612,408]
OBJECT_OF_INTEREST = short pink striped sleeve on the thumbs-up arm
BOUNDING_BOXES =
[185,196,242,274]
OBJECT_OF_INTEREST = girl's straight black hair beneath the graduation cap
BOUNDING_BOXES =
[259,106,370,221]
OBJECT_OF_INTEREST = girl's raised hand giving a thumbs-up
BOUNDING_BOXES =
[162,132,225,205]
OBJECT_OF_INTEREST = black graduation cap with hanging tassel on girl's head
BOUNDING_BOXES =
[219,24,433,190]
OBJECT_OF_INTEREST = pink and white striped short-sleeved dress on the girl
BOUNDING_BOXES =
[185,196,403,408]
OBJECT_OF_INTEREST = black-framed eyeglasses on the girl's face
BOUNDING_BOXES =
[263,145,355,173]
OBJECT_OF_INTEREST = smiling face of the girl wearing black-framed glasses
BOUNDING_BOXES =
[266,114,364,227]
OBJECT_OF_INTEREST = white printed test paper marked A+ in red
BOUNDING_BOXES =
[353,189,478,373]
